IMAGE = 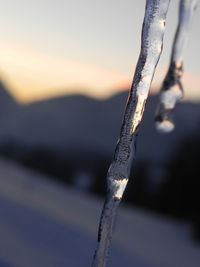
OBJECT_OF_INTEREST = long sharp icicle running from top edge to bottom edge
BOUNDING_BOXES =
[92,0,170,267]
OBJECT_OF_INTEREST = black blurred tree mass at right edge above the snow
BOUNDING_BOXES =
[159,133,200,241]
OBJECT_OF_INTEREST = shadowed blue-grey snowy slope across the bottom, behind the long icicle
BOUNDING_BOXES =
[0,159,200,267]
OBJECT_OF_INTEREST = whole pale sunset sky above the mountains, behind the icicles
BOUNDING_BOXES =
[0,0,200,102]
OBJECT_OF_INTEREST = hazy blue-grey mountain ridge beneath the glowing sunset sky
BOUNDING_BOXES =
[0,84,200,172]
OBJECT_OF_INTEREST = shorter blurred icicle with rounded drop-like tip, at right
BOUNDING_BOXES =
[155,0,198,133]
